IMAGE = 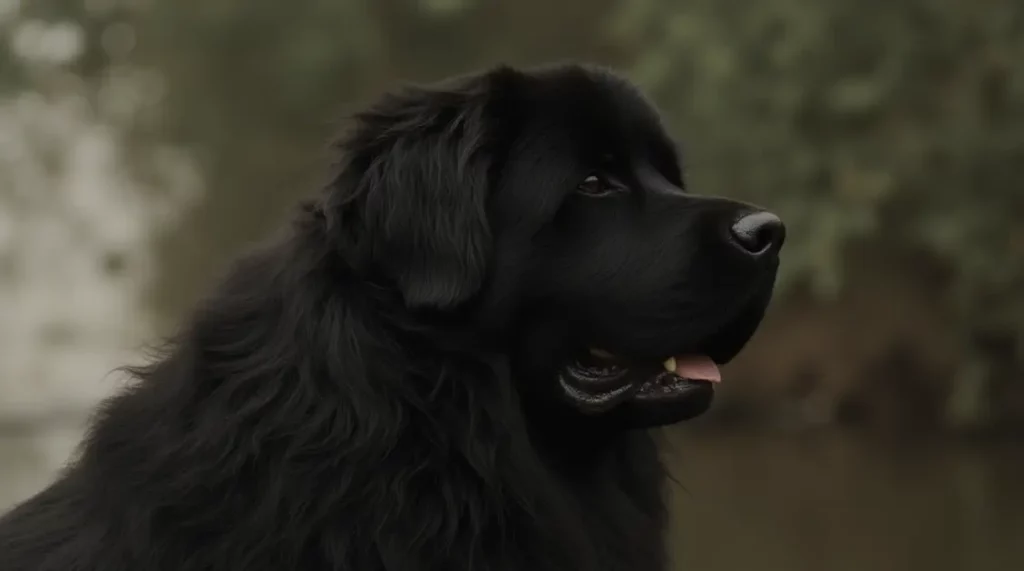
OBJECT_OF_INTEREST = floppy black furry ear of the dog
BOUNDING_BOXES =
[327,78,494,309]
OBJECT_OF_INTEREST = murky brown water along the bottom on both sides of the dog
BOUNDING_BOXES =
[0,431,1024,571]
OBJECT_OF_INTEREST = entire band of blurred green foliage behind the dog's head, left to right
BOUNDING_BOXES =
[0,0,1024,429]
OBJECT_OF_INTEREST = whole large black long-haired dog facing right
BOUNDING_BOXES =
[0,65,783,571]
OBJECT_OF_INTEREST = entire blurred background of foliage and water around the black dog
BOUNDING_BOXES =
[0,0,1024,571]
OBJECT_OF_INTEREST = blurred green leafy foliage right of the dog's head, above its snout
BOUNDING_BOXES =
[612,0,1024,429]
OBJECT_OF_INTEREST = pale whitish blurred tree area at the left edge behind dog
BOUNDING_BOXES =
[0,0,195,431]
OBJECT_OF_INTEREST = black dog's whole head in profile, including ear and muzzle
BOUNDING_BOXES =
[327,65,784,427]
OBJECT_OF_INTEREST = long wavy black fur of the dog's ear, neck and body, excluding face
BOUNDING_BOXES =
[0,70,667,571]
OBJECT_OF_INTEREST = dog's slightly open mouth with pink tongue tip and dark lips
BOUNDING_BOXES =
[559,348,722,413]
